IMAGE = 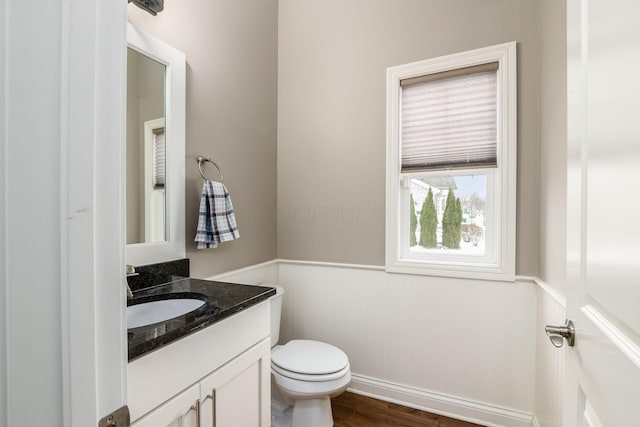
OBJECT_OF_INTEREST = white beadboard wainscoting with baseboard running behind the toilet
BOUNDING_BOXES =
[208,260,564,427]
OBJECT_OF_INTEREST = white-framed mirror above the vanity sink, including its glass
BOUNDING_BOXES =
[125,24,186,265]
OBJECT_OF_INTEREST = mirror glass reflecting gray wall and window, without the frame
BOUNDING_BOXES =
[127,48,171,244]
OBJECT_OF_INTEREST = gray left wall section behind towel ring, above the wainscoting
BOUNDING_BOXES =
[128,0,278,277]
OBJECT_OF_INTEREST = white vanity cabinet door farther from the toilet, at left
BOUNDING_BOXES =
[131,384,200,427]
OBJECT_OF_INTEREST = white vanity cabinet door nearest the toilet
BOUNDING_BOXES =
[200,338,271,427]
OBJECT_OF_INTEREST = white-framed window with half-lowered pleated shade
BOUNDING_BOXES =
[386,42,516,281]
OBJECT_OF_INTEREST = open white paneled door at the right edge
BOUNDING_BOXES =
[564,0,640,427]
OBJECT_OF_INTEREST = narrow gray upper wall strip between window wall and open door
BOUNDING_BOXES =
[538,0,567,294]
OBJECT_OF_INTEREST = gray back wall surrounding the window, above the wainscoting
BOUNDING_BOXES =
[278,0,539,275]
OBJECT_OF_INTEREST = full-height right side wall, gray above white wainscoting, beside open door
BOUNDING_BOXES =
[535,0,567,427]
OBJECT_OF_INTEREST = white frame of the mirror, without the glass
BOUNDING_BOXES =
[123,24,187,265]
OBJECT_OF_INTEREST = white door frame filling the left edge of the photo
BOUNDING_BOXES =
[0,0,127,427]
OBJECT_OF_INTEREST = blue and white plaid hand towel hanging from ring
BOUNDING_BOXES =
[194,181,240,249]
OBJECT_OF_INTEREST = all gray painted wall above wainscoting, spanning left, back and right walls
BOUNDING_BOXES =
[129,0,566,284]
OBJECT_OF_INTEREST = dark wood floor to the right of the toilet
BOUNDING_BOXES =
[331,392,478,427]
